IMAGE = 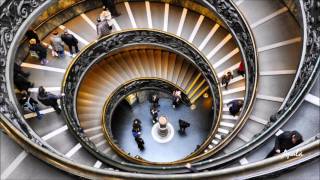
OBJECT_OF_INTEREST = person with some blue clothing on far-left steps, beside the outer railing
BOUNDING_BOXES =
[20,91,43,119]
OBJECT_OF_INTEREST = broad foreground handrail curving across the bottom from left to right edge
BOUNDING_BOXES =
[0,116,320,179]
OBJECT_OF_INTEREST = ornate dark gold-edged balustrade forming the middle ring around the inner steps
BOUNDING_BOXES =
[62,29,222,164]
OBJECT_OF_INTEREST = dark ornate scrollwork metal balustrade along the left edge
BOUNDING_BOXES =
[0,0,47,148]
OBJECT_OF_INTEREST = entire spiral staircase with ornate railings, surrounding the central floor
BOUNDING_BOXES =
[0,0,320,179]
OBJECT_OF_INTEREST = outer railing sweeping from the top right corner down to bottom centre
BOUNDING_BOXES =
[188,0,320,168]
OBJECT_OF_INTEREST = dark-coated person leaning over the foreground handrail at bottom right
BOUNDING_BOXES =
[266,131,303,158]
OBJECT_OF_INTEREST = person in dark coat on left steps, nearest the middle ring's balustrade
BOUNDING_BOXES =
[38,86,61,114]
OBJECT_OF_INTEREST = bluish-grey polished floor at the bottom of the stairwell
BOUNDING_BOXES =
[112,95,212,162]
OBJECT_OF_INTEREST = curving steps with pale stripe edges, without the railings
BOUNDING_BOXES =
[1,0,319,179]
